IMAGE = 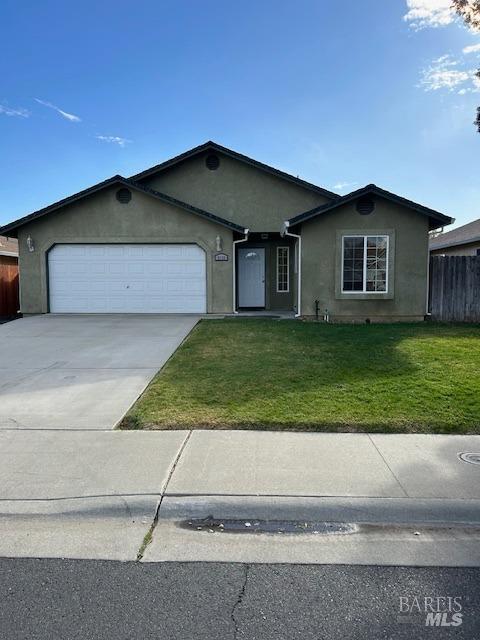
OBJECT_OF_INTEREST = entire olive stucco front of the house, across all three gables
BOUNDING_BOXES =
[14,175,436,321]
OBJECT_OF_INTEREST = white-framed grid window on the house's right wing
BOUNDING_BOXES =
[342,235,389,293]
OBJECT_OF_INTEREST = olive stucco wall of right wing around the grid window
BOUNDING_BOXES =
[301,197,429,321]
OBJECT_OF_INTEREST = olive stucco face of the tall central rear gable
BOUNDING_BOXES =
[142,152,330,233]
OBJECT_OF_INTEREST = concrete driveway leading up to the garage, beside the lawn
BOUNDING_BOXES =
[0,315,198,430]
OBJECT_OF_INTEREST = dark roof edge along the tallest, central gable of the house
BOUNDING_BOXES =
[131,140,340,199]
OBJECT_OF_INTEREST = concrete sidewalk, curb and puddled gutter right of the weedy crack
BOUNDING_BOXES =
[144,431,480,566]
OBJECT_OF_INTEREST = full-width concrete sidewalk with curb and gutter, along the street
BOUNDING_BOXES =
[0,431,480,566]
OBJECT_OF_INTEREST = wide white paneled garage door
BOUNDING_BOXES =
[48,244,207,313]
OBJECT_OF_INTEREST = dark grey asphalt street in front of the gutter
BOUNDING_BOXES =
[0,558,480,640]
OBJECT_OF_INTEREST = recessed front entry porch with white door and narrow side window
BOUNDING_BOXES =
[235,233,297,315]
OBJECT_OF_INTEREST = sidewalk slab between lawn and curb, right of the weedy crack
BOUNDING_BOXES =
[162,431,480,499]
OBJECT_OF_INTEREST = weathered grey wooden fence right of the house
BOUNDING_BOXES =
[429,256,480,322]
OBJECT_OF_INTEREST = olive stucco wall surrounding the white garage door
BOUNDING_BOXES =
[18,186,233,314]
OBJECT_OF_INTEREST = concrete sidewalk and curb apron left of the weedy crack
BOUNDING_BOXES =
[0,431,186,560]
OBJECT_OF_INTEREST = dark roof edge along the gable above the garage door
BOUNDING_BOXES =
[0,175,246,238]
